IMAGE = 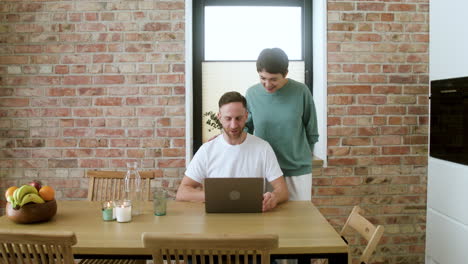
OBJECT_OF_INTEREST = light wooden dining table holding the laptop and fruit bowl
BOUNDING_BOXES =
[0,200,348,264]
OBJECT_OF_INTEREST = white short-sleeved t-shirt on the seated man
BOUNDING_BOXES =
[185,134,283,183]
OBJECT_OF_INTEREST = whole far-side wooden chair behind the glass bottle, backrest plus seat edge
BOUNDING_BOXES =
[79,170,154,264]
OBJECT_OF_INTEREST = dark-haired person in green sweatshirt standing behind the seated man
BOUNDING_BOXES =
[246,48,319,200]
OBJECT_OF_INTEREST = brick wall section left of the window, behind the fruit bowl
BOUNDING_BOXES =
[0,1,185,201]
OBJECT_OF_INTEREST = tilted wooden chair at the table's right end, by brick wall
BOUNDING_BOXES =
[340,206,384,263]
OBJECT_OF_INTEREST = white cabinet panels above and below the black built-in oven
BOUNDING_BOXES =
[426,0,468,264]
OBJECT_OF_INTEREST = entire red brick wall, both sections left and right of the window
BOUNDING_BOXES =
[0,0,429,264]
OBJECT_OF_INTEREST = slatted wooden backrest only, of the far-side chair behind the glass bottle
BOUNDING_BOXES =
[87,170,154,201]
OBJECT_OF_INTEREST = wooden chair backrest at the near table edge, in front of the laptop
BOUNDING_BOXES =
[142,233,278,264]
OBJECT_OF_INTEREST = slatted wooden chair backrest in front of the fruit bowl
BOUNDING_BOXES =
[0,230,76,264]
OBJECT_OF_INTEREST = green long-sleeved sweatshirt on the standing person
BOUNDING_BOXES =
[246,79,319,176]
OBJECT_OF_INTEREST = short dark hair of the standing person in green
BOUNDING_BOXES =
[257,48,289,76]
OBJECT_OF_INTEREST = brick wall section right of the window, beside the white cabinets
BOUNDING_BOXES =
[313,0,429,263]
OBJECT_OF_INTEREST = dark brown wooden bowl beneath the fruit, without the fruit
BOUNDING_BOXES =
[6,200,57,224]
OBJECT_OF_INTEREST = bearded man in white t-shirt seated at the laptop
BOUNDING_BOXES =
[176,92,289,211]
